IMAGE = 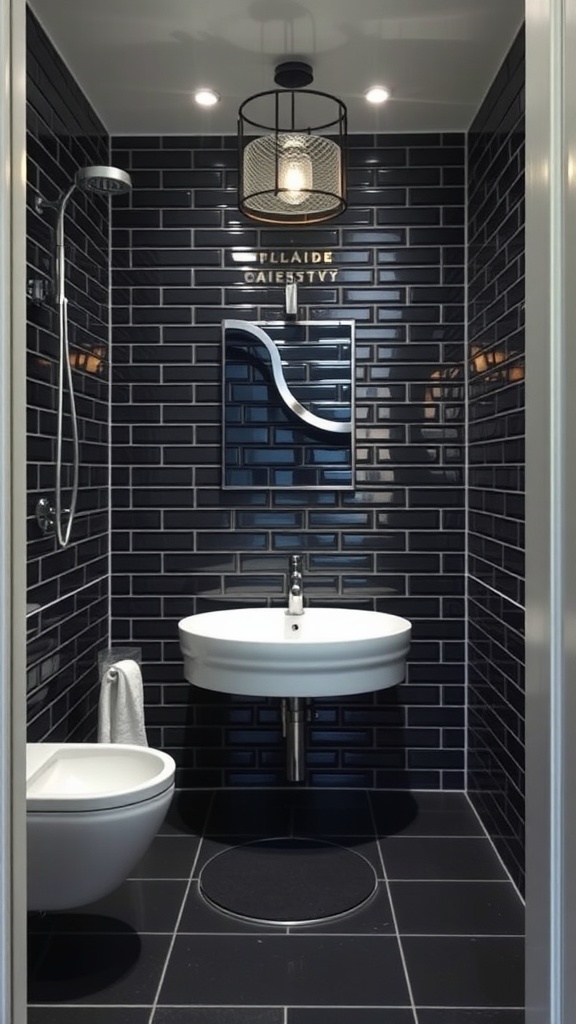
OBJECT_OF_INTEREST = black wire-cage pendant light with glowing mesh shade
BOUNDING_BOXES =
[238,60,346,224]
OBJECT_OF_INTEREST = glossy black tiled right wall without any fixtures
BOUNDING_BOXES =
[468,28,525,886]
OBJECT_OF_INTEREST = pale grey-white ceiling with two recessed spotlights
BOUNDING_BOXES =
[30,0,524,135]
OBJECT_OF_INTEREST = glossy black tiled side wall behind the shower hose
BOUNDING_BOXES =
[27,11,110,740]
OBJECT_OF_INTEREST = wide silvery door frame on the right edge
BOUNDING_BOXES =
[526,0,576,1024]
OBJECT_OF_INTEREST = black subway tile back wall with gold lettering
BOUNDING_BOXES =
[112,134,465,790]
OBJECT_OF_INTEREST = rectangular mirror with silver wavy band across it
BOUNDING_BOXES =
[222,319,355,490]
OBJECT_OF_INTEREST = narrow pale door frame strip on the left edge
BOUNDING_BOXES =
[0,0,27,1024]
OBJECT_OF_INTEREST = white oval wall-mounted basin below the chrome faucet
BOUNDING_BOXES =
[178,608,412,697]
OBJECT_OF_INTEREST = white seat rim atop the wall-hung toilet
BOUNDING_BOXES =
[26,743,174,814]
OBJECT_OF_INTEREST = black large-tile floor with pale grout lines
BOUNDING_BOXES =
[29,788,524,1024]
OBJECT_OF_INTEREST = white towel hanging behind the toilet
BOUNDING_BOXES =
[98,658,148,746]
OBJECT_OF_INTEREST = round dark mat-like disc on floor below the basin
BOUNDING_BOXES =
[200,838,377,925]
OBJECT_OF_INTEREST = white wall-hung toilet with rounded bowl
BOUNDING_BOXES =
[26,743,175,910]
